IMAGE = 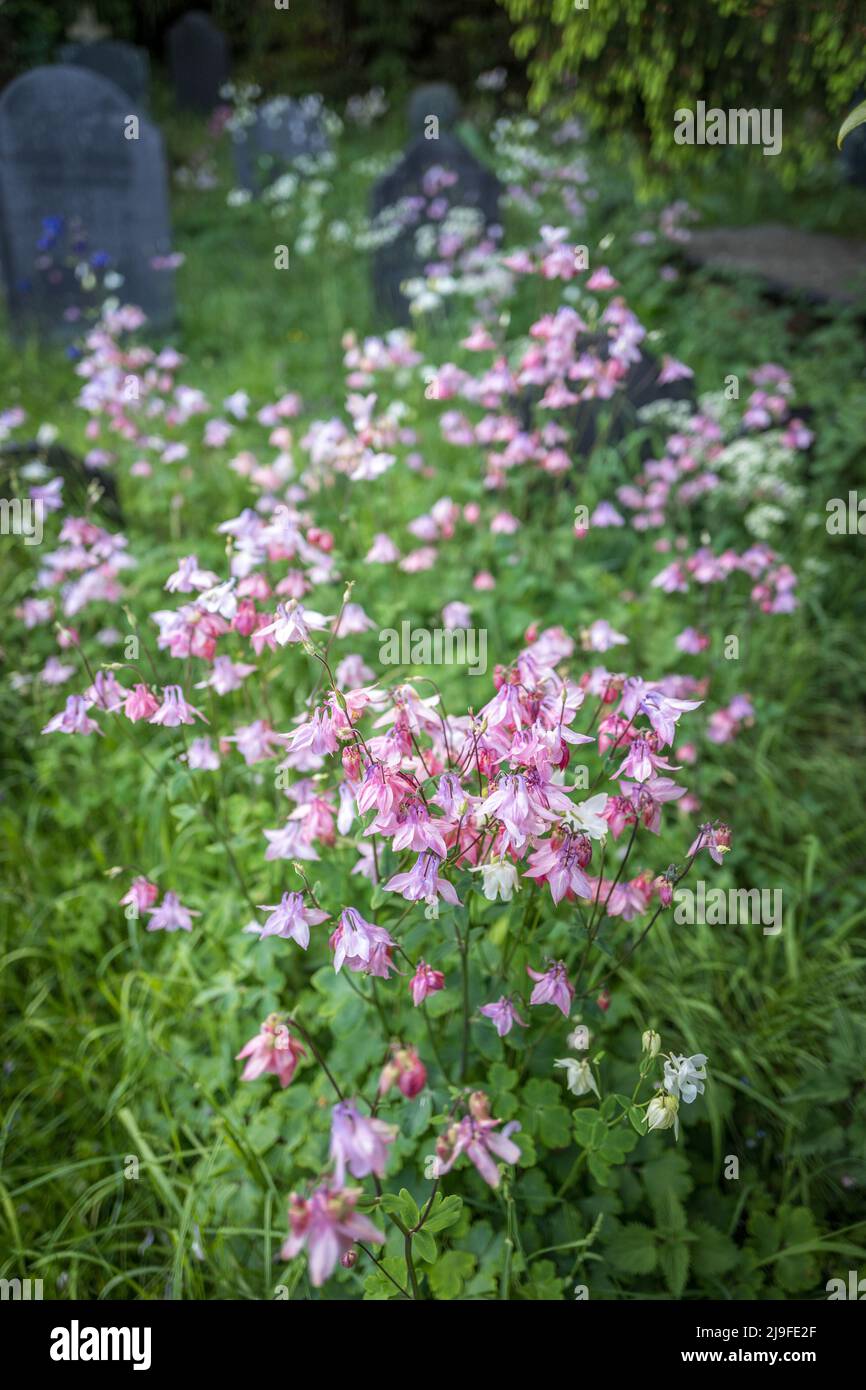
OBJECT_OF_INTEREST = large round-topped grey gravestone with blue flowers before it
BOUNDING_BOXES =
[0,65,174,336]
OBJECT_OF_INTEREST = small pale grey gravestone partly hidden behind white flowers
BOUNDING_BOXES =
[232,96,331,193]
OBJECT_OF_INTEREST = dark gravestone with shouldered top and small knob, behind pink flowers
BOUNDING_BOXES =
[371,132,500,324]
